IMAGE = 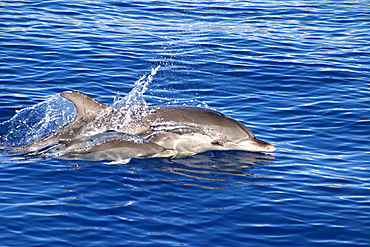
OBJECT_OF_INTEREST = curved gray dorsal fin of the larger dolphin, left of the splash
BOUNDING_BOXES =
[60,91,109,121]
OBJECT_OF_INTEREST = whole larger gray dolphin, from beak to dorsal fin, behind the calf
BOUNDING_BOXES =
[31,91,276,159]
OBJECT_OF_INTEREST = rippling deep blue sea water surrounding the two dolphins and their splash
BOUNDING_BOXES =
[0,0,370,246]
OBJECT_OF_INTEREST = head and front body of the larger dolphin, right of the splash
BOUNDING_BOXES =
[137,106,276,158]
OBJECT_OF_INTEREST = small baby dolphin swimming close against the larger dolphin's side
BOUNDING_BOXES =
[28,131,175,164]
